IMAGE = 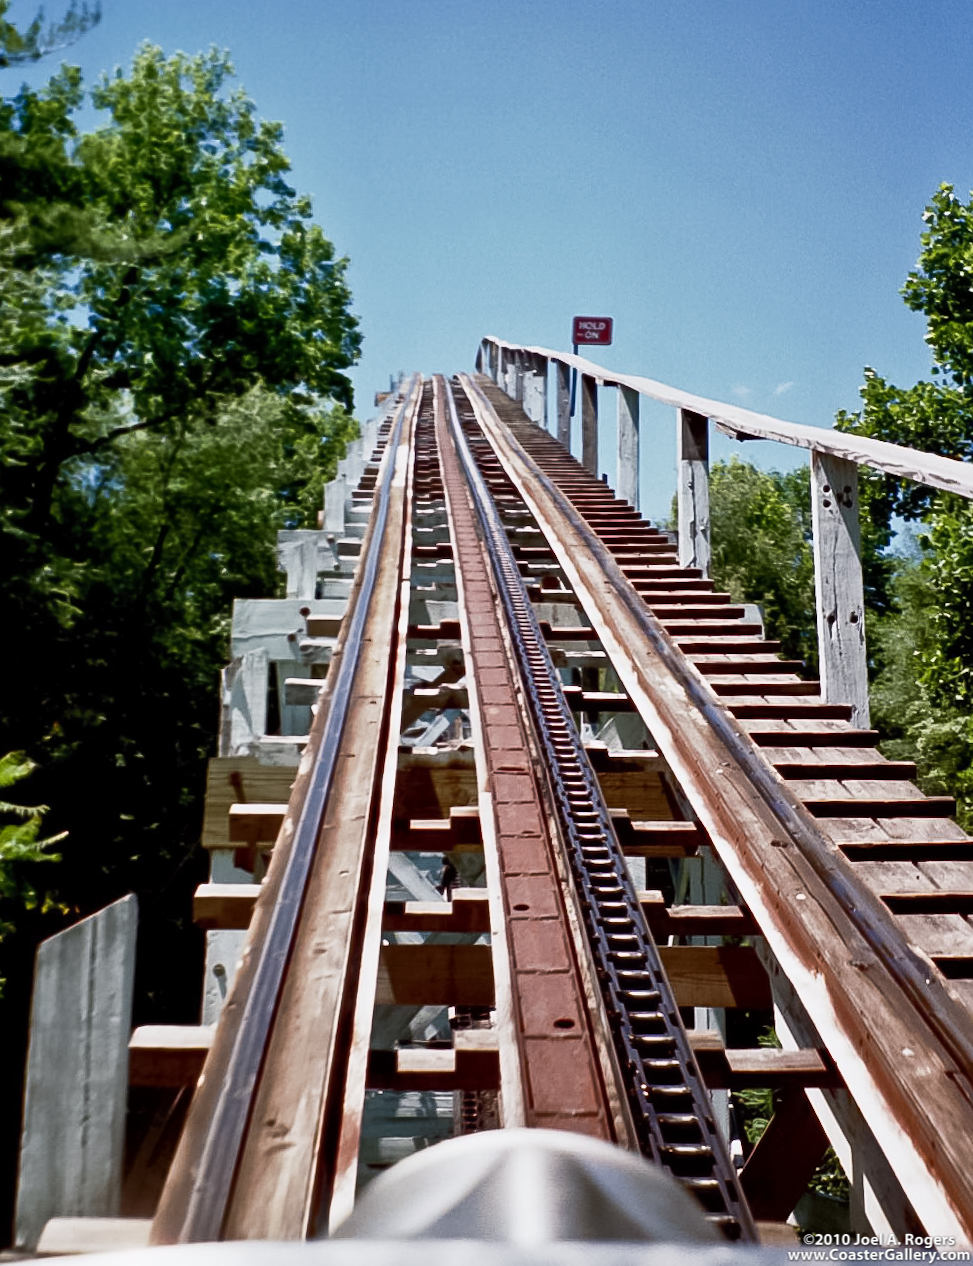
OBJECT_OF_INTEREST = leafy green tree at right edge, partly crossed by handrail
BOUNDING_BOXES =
[836,185,973,823]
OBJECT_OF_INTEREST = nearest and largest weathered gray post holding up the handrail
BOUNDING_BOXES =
[811,451,868,729]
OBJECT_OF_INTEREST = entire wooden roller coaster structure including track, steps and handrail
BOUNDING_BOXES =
[15,339,973,1243]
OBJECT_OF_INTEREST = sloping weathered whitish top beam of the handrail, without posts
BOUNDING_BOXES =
[485,339,973,500]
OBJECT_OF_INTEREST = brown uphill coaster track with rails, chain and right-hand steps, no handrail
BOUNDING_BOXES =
[142,375,973,1243]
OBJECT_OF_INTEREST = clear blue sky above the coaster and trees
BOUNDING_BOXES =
[4,0,973,515]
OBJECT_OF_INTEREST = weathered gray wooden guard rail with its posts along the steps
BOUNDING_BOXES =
[477,337,973,728]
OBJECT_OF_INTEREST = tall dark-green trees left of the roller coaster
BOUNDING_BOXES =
[0,32,359,1235]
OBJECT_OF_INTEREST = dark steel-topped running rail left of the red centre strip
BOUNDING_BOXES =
[153,385,415,1243]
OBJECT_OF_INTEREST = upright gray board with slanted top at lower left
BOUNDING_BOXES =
[15,896,138,1248]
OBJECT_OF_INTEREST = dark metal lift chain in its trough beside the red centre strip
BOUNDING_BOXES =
[445,385,757,1239]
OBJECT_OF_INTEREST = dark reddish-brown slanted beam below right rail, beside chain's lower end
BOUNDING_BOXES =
[740,1086,827,1222]
